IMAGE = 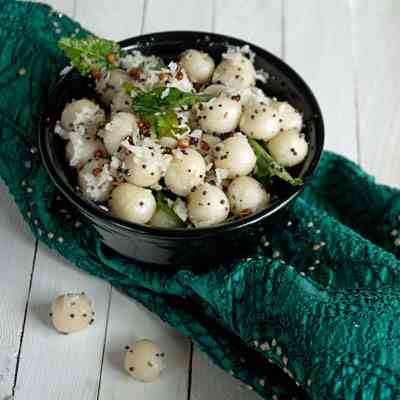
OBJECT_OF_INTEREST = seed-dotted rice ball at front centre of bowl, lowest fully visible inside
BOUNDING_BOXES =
[187,183,229,227]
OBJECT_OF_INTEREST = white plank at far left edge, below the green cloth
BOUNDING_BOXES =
[0,182,35,399]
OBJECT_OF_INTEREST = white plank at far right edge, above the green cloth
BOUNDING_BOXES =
[350,0,400,185]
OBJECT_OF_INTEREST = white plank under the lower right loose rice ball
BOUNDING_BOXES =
[99,290,189,400]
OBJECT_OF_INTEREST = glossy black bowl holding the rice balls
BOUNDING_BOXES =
[39,32,324,267]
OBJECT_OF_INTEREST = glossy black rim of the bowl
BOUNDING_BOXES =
[39,30,325,239]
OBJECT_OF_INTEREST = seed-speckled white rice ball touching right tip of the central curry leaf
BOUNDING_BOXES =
[197,95,242,133]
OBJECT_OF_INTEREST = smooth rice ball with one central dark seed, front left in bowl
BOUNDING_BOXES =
[109,183,156,224]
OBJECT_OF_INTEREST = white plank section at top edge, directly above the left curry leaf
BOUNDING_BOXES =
[76,0,144,40]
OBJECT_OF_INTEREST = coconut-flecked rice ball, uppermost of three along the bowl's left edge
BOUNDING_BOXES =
[61,99,105,135]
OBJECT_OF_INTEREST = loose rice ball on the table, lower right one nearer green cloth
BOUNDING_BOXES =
[124,339,165,382]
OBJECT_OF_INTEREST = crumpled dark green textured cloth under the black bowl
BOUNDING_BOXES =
[0,0,400,400]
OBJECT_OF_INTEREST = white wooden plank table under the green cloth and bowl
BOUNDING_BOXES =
[0,0,400,400]
